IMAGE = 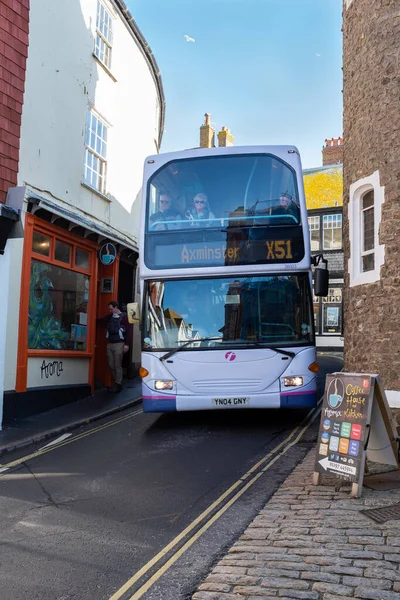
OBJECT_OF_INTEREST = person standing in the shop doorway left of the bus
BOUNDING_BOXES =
[97,300,132,394]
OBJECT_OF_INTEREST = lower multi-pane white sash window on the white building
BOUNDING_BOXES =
[84,108,109,194]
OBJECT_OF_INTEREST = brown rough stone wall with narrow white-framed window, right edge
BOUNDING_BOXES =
[343,0,400,407]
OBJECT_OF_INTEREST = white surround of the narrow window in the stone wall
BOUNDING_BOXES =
[348,171,385,287]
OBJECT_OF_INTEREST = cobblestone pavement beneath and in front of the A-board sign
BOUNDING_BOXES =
[192,450,400,600]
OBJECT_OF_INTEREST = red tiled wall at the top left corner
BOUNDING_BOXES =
[0,0,29,202]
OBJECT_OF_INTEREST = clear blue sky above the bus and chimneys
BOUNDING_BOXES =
[129,0,342,168]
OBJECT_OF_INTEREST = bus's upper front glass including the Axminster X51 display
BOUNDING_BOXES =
[144,154,304,269]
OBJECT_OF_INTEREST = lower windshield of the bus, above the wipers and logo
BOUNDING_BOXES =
[143,273,314,351]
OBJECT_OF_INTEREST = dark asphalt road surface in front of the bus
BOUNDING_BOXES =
[0,355,342,600]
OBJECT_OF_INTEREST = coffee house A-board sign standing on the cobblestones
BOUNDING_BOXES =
[314,372,399,497]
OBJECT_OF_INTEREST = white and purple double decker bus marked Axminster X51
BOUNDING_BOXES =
[140,146,328,412]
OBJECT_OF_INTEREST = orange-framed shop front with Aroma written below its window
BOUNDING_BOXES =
[3,211,136,423]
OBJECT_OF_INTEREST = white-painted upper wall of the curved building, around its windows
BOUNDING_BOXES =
[18,0,158,245]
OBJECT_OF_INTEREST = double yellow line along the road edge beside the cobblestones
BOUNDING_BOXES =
[110,405,319,600]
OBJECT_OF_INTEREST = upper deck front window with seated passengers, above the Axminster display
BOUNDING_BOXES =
[147,154,300,231]
